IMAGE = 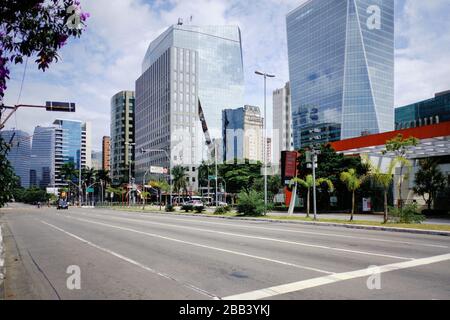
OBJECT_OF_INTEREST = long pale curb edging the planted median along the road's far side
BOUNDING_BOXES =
[99,208,450,237]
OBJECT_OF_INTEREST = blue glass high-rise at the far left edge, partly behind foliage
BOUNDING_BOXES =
[0,130,31,188]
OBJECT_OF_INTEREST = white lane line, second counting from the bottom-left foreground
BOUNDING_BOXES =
[66,217,334,274]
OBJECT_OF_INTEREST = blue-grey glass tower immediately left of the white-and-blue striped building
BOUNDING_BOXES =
[30,126,55,188]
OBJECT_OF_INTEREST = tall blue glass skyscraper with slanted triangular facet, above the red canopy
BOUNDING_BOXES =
[287,0,394,148]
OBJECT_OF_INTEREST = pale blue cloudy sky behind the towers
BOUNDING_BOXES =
[5,0,450,149]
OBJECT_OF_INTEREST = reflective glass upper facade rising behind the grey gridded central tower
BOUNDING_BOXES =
[142,25,244,138]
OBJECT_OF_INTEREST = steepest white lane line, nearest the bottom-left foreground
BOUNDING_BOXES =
[41,220,217,299]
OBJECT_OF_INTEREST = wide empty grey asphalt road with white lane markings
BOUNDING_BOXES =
[0,207,450,300]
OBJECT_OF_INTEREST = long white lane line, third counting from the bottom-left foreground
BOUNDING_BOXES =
[84,214,414,260]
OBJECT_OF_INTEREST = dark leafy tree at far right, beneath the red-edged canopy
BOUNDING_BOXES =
[414,159,446,210]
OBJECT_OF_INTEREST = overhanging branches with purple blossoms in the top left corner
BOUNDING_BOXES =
[0,0,89,97]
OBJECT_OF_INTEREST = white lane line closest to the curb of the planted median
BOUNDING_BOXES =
[87,211,449,249]
